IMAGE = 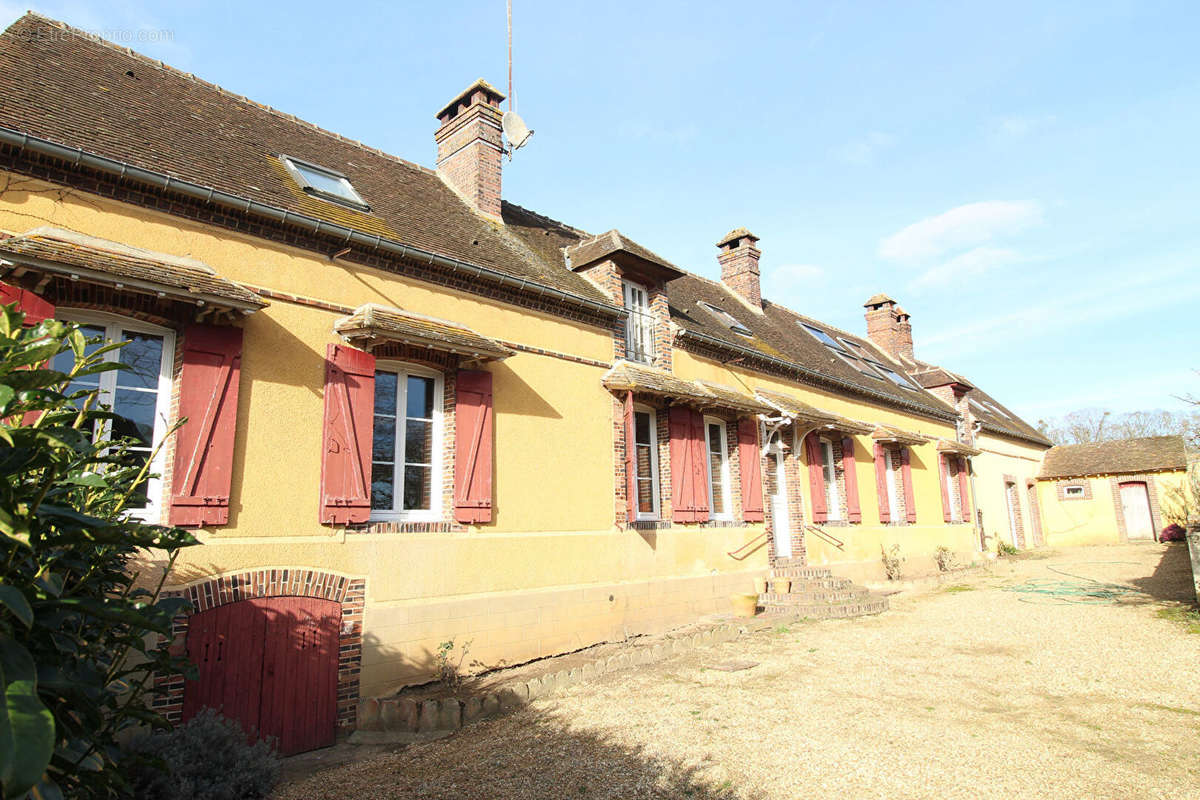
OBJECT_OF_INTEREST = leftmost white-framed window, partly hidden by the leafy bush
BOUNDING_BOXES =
[50,309,175,522]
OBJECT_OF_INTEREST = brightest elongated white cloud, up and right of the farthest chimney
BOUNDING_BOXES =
[880,200,1042,264]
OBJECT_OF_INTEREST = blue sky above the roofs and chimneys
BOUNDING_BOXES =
[0,0,1200,421]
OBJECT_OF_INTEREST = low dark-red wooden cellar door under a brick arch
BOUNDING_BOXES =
[184,597,341,756]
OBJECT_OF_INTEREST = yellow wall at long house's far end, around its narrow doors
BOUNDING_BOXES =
[971,432,1046,551]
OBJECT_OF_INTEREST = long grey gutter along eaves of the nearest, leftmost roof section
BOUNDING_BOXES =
[0,126,628,318]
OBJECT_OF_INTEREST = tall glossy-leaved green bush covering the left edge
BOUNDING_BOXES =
[0,307,194,800]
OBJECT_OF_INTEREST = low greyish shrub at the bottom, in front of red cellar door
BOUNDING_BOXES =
[130,709,280,800]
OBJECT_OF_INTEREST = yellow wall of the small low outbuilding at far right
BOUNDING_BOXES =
[1038,470,1186,547]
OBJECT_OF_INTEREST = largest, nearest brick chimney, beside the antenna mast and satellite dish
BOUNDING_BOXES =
[433,78,504,222]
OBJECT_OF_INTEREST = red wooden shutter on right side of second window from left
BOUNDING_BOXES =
[454,369,493,523]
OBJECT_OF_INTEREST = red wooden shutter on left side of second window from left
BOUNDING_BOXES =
[320,344,374,525]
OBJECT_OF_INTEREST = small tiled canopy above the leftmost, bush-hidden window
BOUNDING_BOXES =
[0,227,266,312]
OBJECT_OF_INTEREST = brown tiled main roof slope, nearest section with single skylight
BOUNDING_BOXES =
[0,14,611,303]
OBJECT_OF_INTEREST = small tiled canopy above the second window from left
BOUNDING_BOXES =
[334,303,514,361]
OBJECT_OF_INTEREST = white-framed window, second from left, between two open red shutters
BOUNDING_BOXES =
[371,363,443,522]
